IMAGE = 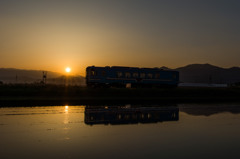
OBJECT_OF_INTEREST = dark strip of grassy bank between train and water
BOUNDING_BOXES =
[0,84,240,106]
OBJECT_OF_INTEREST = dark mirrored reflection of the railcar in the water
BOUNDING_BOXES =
[85,106,179,125]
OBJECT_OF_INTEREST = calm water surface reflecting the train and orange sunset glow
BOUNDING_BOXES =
[0,104,240,159]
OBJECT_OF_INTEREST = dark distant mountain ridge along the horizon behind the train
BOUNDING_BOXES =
[0,64,240,84]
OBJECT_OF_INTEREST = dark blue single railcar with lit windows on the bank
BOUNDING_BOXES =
[86,66,179,87]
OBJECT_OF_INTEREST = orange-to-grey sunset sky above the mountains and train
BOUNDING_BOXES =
[0,0,240,75]
